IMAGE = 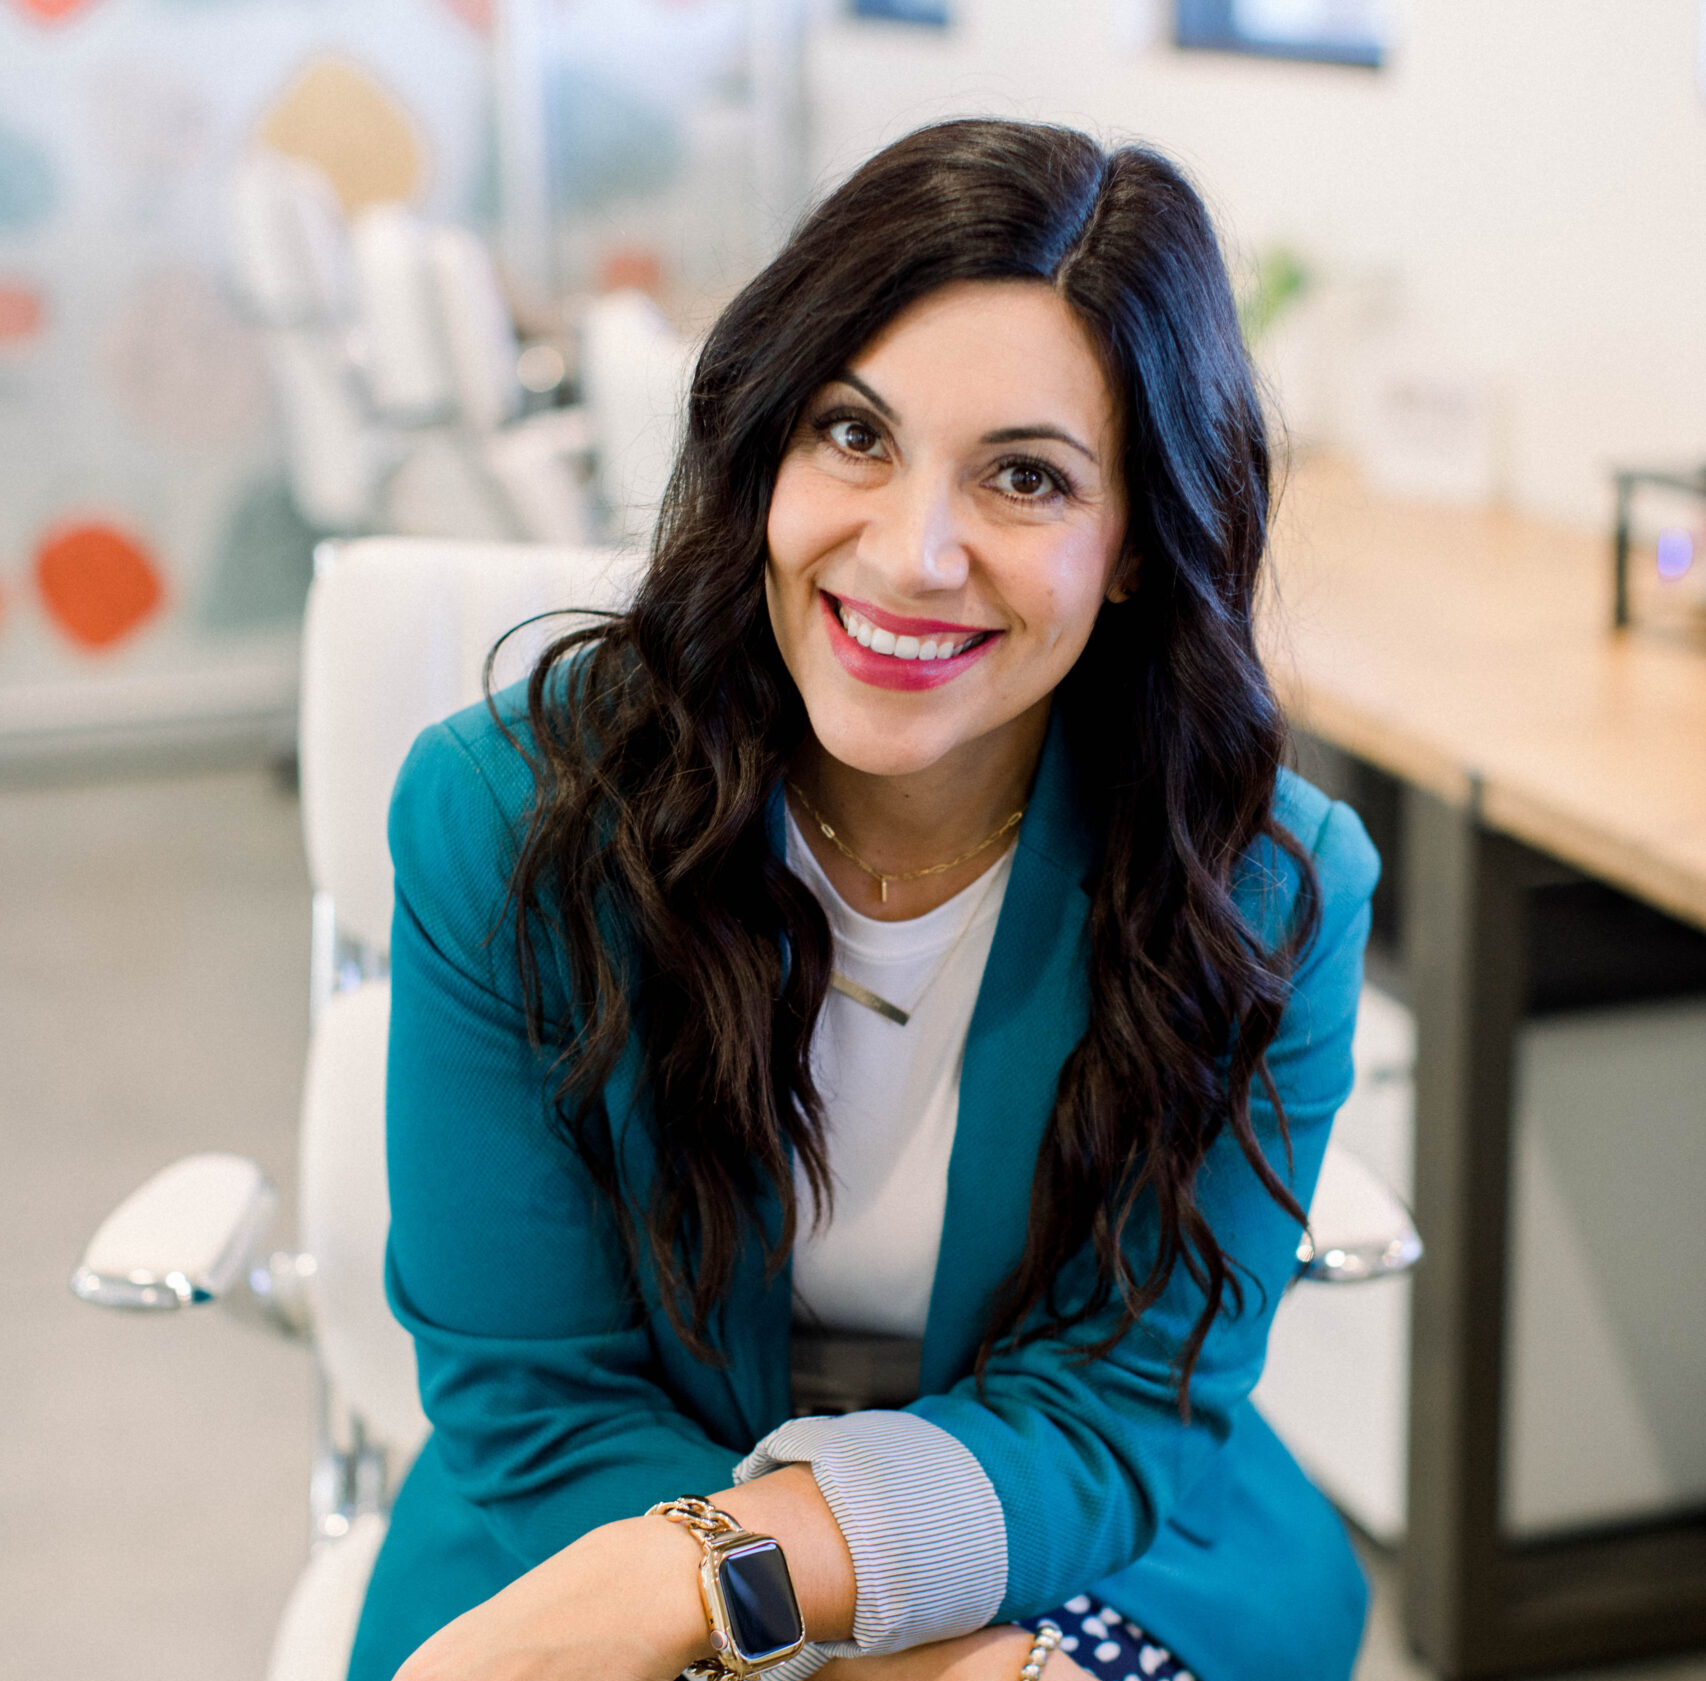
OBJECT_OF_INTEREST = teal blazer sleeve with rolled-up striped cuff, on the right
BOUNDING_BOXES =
[742,795,1378,1650]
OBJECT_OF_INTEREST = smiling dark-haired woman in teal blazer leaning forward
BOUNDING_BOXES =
[351,121,1375,1681]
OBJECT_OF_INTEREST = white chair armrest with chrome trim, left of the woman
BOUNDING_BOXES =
[72,1152,314,1336]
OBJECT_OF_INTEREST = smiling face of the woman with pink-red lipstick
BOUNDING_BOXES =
[766,280,1126,775]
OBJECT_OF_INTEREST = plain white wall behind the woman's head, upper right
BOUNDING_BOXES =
[810,0,1706,522]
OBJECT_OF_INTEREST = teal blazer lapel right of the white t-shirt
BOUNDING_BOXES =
[921,710,1094,1394]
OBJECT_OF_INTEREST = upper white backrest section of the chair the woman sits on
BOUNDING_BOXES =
[300,538,636,954]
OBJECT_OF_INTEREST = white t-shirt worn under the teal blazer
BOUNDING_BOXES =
[788,812,1013,1336]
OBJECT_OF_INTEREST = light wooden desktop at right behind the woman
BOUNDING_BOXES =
[1266,469,1706,927]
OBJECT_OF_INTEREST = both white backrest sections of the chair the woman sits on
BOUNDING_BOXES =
[300,538,633,1464]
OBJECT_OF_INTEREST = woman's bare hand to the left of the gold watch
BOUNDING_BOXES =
[396,1517,711,1681]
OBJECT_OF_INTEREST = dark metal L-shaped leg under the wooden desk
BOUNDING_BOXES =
[1404,788,1706,1681]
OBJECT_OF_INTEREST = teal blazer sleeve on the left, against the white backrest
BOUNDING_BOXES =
[386,710,739,1567]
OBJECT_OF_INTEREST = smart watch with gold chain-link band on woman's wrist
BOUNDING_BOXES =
[647,1495,805,1681]
